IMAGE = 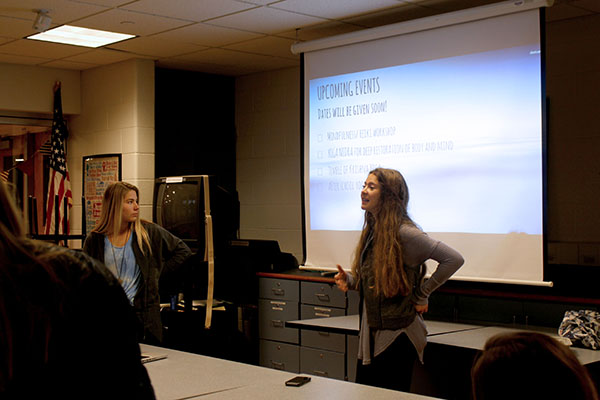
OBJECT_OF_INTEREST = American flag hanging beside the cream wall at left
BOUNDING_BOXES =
[45,82,73,235]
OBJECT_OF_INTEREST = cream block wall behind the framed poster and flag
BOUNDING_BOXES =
[0,59,154,242]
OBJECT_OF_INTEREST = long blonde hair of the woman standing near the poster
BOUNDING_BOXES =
[92,182,152,254]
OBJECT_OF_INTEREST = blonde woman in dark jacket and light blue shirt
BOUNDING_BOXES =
[83,182,191,344]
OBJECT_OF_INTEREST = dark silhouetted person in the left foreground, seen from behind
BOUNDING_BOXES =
[0,182,154,399]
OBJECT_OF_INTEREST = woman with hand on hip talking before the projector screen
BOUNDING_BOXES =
[335,168,463,391]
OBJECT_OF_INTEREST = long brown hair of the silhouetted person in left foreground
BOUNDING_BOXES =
[0,181,65,388]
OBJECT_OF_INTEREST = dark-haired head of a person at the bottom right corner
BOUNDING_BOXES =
[471,332,598,400]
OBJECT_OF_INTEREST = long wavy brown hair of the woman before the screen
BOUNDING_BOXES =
[352,168,414,297]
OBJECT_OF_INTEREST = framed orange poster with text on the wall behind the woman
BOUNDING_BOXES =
[83,154,121,236]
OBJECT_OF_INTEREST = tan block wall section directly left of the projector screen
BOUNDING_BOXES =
[235,68,302,262]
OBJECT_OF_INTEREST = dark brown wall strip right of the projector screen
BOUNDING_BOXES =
[546,15,600,266]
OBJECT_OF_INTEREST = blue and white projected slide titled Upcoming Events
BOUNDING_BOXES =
[308,44,542,235]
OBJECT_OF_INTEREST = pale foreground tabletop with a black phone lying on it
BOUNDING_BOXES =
[140,344,440,400]
